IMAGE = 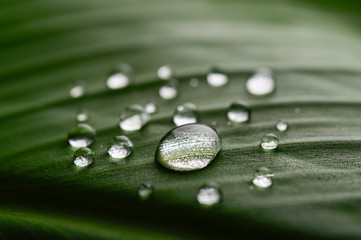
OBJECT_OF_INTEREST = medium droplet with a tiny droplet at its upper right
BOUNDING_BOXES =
[119,104,150,131]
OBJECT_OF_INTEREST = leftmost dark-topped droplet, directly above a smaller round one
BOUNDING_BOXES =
[68,123,95,148]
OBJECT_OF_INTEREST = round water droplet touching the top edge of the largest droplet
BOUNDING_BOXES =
[173,103,198,126]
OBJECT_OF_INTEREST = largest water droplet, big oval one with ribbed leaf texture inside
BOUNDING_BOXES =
[155,123,222,171]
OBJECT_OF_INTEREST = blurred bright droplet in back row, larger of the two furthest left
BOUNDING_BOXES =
[106,63,132,89]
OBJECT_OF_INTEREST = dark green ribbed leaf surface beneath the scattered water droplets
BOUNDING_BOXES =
[0,0,361,239]
